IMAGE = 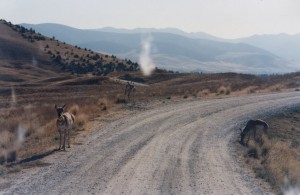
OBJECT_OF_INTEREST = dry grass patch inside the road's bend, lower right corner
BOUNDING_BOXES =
[243,109,300,194]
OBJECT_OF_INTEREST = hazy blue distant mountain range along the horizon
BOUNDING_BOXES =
[21,23,300,74]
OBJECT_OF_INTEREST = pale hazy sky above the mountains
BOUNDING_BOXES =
[0,0,300,38]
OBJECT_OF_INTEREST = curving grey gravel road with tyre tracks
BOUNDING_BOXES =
[0,92,300,194]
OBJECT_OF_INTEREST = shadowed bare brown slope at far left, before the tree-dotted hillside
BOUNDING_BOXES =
[0,21,58,84]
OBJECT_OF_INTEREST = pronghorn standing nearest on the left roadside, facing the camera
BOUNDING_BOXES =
[55,104,75,150]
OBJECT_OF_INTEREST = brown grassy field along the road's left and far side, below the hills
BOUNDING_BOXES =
[0,72,298,163]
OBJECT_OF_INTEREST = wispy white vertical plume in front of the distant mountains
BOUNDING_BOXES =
[140,36,155,76]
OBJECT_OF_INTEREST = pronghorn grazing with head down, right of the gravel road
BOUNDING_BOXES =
[240,119,269,145]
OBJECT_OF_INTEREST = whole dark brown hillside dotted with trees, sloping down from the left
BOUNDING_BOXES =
[0,20,138,83]
